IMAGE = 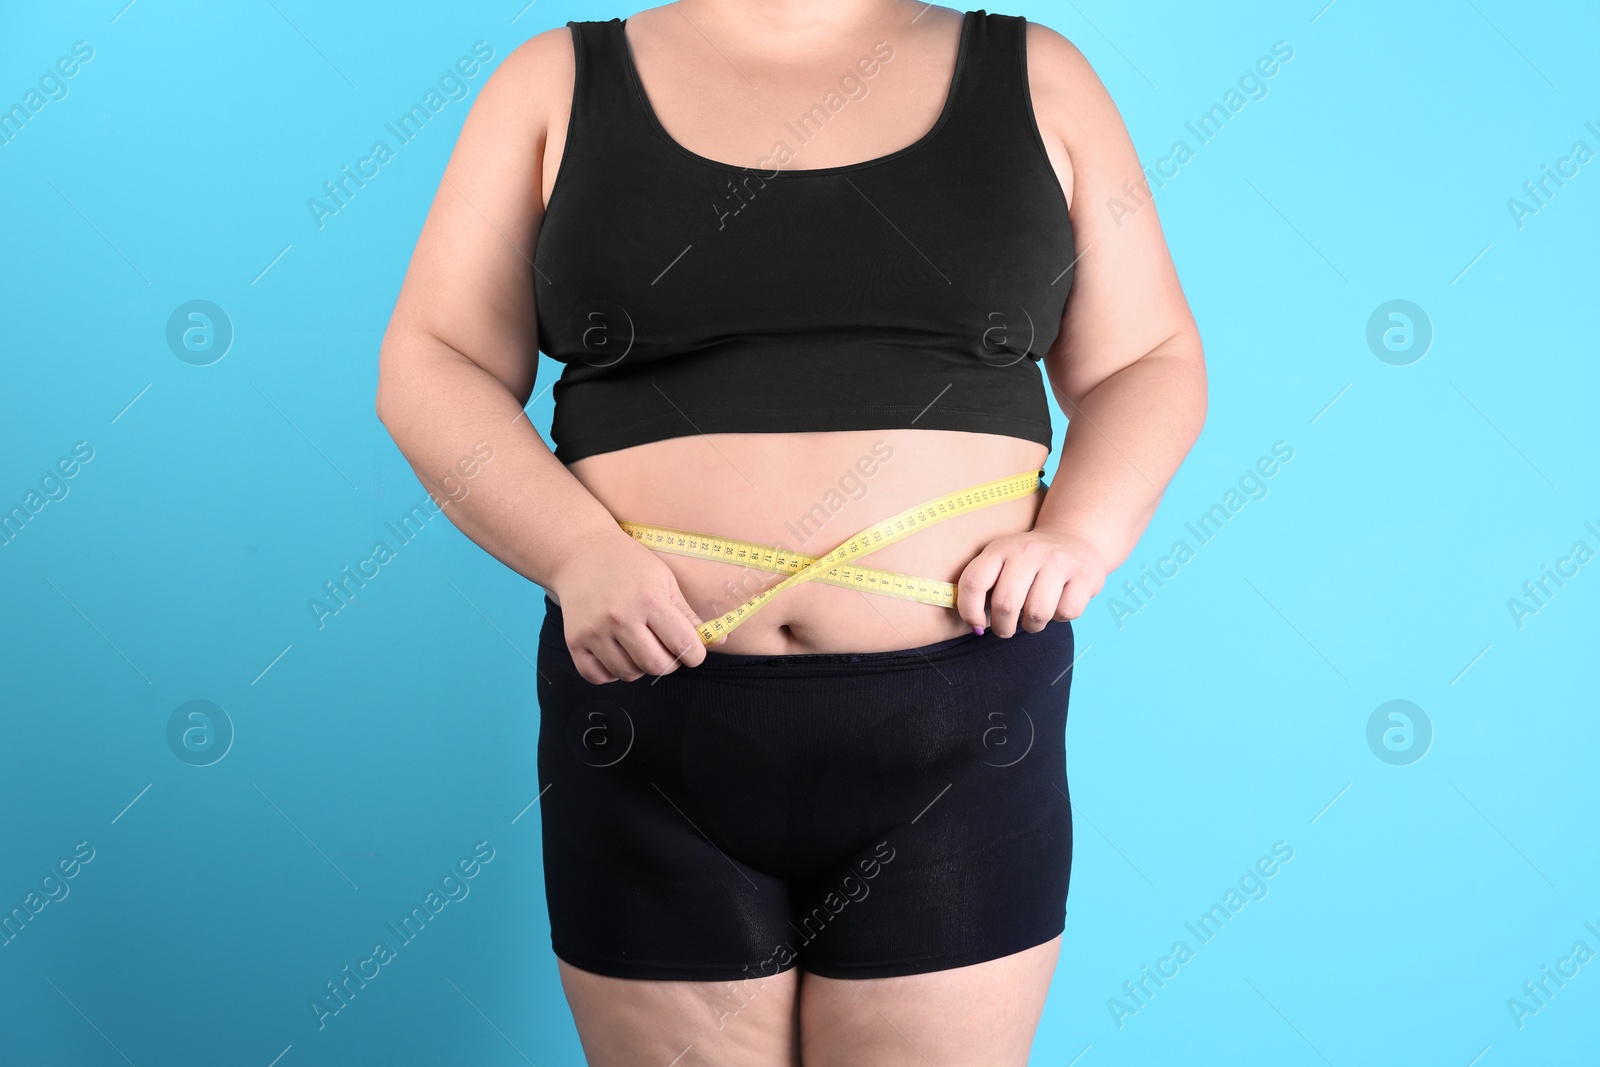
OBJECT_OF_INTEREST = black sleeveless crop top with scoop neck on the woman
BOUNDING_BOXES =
[533,11,1074,462]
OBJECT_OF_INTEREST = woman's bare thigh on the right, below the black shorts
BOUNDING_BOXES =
[800,937,1061,1067]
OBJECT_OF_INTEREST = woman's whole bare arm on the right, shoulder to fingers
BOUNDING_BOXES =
[957,22,1206,637]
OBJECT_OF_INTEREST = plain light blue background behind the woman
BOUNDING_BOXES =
[0,0,1600,1067]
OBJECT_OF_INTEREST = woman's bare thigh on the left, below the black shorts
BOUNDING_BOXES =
[557,960,800,1067]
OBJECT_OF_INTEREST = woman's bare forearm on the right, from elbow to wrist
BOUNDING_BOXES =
[1034,334,1206,573]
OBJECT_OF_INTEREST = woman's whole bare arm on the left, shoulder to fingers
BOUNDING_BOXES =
[376,33,706,683]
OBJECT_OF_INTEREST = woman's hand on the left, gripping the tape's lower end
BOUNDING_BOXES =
[550,534,728,685]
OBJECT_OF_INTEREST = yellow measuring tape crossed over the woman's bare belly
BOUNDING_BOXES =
[619,469,1045,645]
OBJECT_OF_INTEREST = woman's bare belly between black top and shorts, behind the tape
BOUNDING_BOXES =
[568,430,1046,656]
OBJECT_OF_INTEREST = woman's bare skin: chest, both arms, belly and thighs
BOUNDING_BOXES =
[376,0,1206,1067]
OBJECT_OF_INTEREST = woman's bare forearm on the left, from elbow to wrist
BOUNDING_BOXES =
[378,331,627,589]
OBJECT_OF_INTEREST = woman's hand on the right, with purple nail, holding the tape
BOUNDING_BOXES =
[955,530,1106,637]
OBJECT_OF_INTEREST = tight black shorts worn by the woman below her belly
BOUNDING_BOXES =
[536,597,1074,981]
